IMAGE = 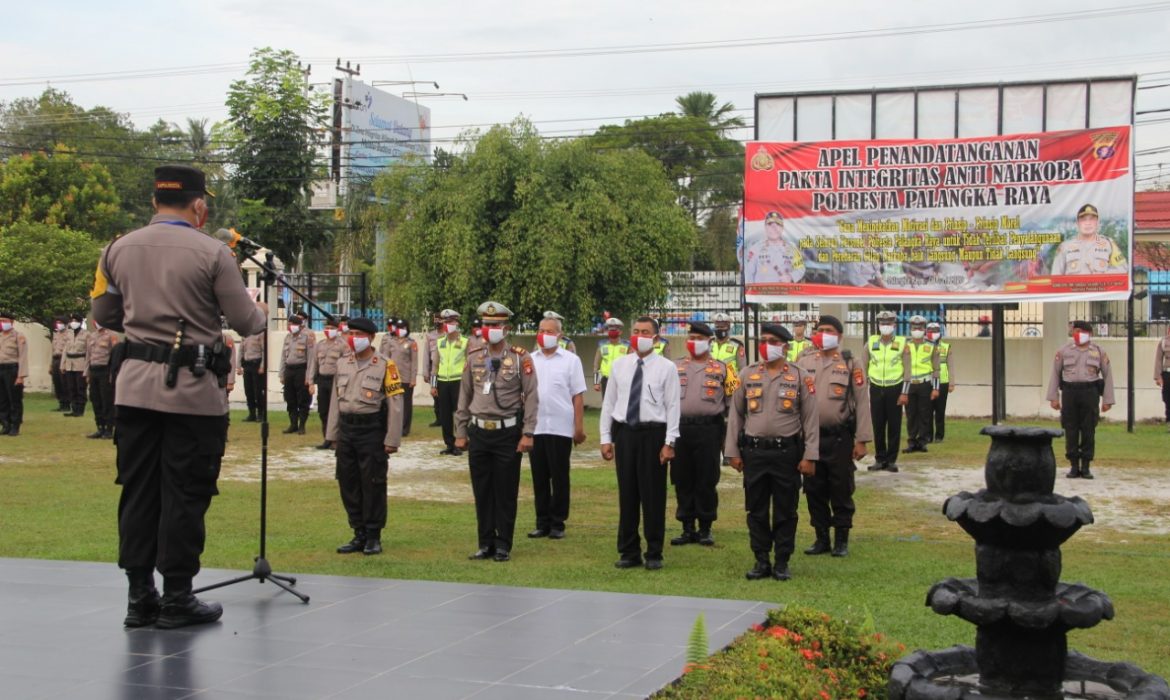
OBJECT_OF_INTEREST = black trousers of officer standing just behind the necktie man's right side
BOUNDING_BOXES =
[670,417,723,530]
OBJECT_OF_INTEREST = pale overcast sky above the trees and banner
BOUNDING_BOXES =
[0,0,1170,186]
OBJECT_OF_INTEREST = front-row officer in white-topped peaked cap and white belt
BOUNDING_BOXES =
[451,301,539,562]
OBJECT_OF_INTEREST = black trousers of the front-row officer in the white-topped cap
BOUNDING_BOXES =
[467,421,522,551]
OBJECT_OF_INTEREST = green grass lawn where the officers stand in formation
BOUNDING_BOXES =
[0,394,1170,677]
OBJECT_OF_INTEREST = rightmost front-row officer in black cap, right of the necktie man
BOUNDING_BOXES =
[723,323,819,581]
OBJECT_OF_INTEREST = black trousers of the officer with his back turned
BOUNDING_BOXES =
[115,406,227,591]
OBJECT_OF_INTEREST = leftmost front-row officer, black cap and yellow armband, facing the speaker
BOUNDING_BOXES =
[318,317,404,555]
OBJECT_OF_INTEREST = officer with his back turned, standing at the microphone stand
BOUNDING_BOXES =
[91,165,267,629]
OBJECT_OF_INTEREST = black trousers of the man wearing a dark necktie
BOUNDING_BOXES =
[613,421,667,560]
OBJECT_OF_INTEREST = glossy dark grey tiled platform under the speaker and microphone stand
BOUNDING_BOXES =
[0,558,775,700]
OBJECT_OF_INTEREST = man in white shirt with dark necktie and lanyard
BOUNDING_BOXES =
[601,316,680,570]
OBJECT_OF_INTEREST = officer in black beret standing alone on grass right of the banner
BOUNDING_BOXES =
[1047,321,1115,479]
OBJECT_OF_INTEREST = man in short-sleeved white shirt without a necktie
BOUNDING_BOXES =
[528,315,585,540]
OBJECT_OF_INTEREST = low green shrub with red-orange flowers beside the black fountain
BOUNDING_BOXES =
[653,606,906,700]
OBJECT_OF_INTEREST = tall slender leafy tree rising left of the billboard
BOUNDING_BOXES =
[227,48,329,268]
